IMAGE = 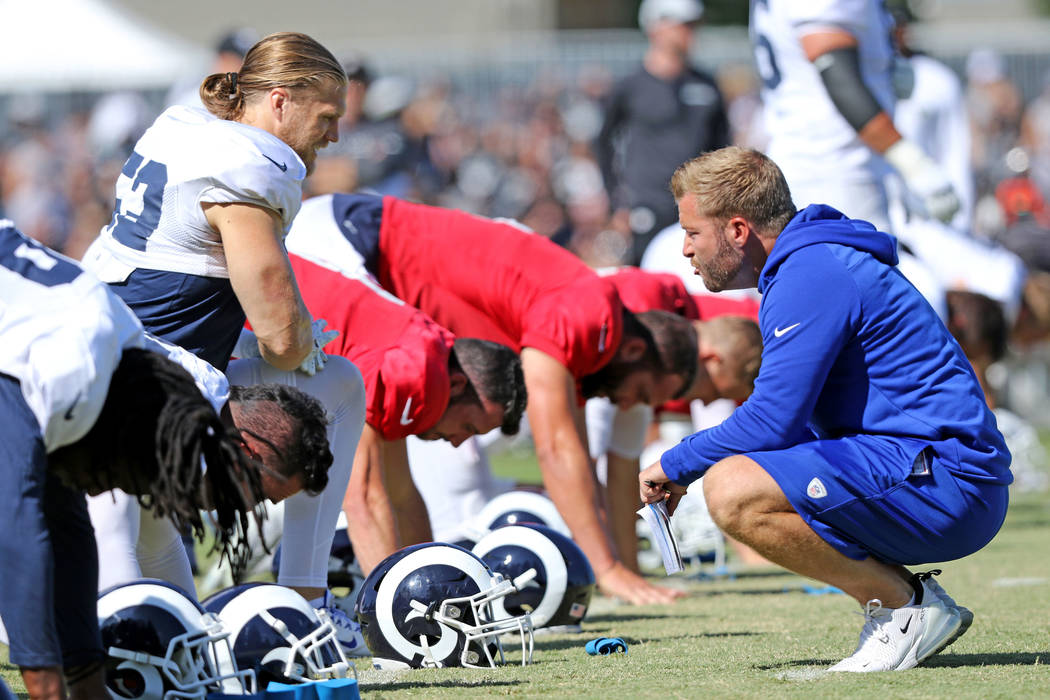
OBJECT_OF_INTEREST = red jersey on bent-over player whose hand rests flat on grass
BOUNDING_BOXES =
[377,197,623,380]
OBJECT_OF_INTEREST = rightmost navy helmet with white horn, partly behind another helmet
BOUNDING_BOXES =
[474,523,594,628]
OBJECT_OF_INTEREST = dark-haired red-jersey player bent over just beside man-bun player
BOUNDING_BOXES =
[279,254,526,574]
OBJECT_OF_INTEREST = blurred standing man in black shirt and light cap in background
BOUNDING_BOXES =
[595,0,730,264]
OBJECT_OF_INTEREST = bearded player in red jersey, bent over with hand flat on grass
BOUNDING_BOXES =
[287,194,696,603]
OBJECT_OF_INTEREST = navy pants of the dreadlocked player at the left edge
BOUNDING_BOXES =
[0,375,104,667]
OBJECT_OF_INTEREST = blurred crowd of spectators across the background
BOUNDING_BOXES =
[6,0,1050,449]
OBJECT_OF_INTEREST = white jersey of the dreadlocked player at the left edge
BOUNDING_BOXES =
[0,221,144,452]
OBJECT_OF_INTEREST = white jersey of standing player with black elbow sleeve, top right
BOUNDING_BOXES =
[750,0,895,183]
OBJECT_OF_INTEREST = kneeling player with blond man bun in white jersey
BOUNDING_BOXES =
[85,33,364,646]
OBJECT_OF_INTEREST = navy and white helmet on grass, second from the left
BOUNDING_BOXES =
[204,584,357,687]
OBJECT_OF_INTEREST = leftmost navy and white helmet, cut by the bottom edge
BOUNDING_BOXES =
[98,578,255,700]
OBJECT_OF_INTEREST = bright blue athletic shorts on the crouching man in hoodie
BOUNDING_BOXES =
[747,436,1008,565]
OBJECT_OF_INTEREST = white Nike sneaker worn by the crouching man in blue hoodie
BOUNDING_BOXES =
[831,576,962,673]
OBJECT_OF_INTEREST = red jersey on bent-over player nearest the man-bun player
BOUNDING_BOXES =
[289,254,455,440]
